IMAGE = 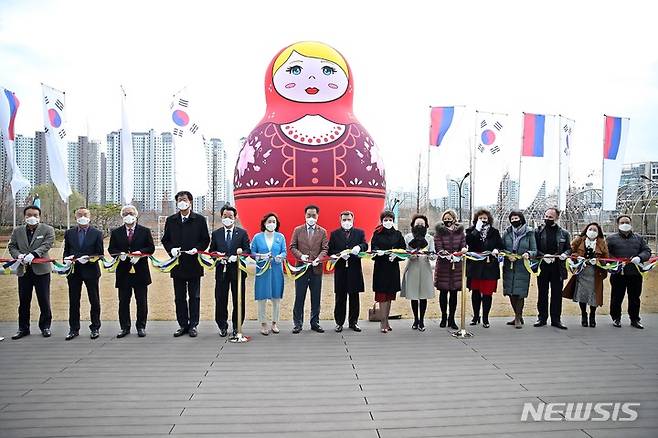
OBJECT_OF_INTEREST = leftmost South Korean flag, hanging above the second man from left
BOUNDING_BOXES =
[41,84,71,202]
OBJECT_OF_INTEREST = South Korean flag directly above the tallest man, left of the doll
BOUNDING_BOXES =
[170,89,208,197]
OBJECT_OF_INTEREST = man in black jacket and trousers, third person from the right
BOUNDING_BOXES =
[534,207,571,329]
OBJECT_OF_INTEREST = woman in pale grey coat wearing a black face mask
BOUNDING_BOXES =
[400,214,434,332]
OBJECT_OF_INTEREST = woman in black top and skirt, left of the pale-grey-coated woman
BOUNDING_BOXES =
[370,210,407,333]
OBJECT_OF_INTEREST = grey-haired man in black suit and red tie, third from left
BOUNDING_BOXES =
[107,205,155,338]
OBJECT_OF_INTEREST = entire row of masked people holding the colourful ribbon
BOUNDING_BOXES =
[9,192,650,340]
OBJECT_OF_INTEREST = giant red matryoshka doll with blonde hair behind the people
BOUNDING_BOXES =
[234,42,386,243]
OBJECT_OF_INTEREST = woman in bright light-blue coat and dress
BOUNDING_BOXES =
[251,213,287,336]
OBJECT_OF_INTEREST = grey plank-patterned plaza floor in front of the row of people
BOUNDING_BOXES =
[0,315,658,438]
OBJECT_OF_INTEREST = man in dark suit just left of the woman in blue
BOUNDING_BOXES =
[210,205,249,337]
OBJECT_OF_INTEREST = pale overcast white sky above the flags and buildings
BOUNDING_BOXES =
[0,0,658,189]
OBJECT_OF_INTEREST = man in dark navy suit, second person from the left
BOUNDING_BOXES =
[64,207,103,341]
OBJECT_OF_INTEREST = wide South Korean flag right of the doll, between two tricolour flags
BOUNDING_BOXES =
[471,111,508,207]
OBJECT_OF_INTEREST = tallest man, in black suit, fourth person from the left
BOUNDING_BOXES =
[161,191,210,338]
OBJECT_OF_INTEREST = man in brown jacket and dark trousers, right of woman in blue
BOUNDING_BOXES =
[290,205,329,333]
